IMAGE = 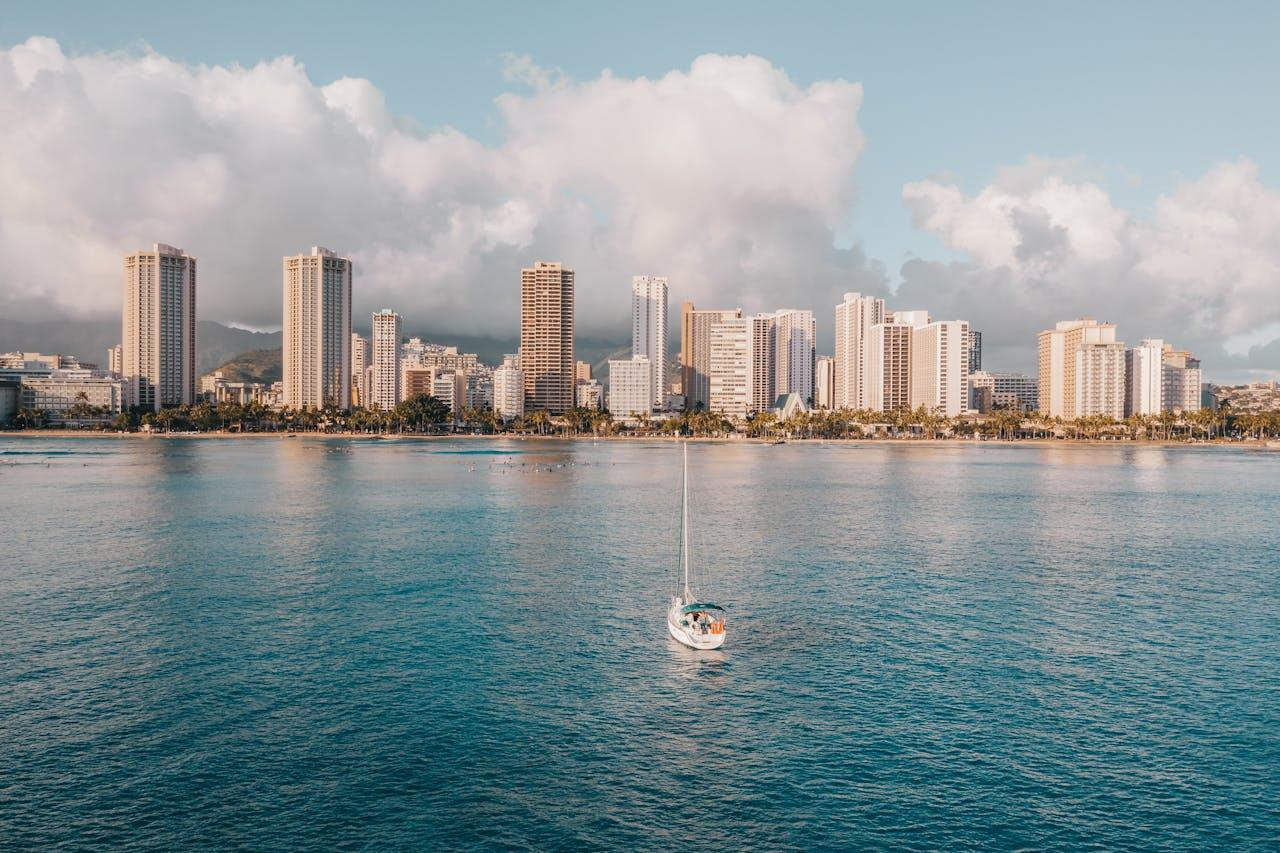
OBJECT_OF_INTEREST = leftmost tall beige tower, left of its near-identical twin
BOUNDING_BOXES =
[120,243,196,411]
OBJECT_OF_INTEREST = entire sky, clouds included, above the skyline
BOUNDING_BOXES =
[0,0,1280,380]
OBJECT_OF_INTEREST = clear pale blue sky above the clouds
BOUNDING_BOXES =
[0,1,1280,270]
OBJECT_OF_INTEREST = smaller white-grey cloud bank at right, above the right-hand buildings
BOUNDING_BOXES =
[899,158,1280,371]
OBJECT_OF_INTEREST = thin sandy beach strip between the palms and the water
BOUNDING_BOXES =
[0,429,1280,451]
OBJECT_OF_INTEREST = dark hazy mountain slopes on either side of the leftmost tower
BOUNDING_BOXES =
[0,318,280,375]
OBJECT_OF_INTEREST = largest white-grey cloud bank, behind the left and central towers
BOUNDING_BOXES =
[0,37,884,337]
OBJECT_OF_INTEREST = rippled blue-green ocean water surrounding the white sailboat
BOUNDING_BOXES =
[0,437,1280,850]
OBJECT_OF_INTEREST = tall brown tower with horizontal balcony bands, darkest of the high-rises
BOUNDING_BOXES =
[520,261,573,415]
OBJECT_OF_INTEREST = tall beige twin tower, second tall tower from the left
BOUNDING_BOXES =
[282,246,351,409]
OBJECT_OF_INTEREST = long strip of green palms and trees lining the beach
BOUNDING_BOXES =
[10,394,1280,442]
